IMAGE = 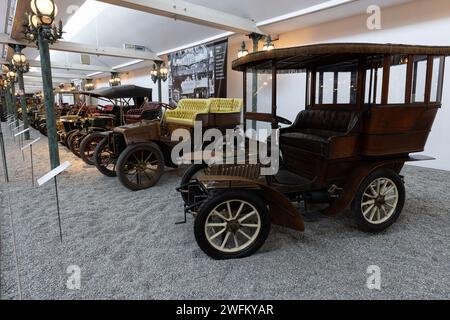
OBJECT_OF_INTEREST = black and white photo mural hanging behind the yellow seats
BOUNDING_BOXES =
[169,40,228,101]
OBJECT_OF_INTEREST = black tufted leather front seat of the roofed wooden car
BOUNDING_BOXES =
[280,110,359,156]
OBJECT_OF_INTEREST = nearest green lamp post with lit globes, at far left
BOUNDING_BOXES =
[24,0,63,169]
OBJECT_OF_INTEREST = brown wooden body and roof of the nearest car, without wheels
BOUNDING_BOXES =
[185,43,450,230]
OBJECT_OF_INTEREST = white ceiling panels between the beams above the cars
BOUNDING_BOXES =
[7,0,412,87]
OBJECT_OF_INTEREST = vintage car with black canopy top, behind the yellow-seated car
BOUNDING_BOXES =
[67,85,152,165]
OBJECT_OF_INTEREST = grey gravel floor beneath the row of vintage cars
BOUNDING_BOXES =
[0,124,450,299]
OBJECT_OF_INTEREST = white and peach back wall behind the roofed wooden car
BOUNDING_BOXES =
[228,0,450,171]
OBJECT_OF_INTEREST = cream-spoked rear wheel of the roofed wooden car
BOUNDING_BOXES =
[351,169,405,232]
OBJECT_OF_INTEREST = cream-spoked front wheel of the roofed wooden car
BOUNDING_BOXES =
[194,190,270,259]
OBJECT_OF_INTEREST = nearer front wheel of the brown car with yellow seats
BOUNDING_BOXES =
[116,143,164,191]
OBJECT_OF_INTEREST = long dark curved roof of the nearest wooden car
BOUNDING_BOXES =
[232,43,450,72]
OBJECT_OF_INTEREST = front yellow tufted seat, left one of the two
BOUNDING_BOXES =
[165,99,211,127]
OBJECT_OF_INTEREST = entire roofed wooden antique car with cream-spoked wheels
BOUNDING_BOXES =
[179,43,450,259]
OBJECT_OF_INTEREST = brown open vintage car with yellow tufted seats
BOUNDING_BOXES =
[94,98,242,190]
